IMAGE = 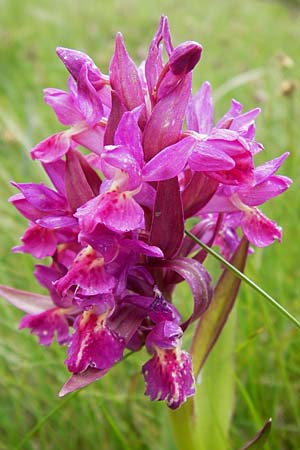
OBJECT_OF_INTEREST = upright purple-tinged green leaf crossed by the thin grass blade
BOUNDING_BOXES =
[191,239,249,377]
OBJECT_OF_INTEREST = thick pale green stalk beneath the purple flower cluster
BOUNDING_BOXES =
[169,309,236,450]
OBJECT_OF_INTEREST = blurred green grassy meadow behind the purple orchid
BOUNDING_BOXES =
[0,0,300,450]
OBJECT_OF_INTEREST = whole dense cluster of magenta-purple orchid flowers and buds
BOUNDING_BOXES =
[1,17,290,408]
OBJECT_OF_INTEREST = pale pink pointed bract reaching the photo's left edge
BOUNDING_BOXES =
[0,285,53,314]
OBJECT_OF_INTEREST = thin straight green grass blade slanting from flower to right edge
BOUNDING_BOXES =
[185,230,300,329]
